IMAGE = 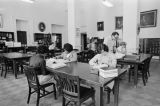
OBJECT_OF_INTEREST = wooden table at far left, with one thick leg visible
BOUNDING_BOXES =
[1,52,32,78]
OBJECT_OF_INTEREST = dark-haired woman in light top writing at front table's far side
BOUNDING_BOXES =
[57,43,77,61]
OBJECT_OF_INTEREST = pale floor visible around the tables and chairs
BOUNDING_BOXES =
[0,60,160,106]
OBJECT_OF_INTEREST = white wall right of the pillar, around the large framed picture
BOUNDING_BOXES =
[139,0,160,38]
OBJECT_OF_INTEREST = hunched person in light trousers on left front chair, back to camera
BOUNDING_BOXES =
[29,46,53,84]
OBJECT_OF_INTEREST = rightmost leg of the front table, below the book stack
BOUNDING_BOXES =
[114,77,119,106]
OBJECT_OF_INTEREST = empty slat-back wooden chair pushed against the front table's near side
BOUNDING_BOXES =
[54,72,95,106]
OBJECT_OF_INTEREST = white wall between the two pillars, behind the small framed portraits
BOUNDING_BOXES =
[76,0,123,38]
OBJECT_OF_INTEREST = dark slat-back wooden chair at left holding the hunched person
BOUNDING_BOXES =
[24,65,56,106]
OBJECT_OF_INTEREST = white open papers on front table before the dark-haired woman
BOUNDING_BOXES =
[46,59,66,69]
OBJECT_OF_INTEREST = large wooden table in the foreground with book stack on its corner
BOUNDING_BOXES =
[47,62,126,106]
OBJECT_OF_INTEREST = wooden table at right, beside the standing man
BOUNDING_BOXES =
[117,54,152,87]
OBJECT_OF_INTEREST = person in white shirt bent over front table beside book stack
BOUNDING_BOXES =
[89,44,117,89]
